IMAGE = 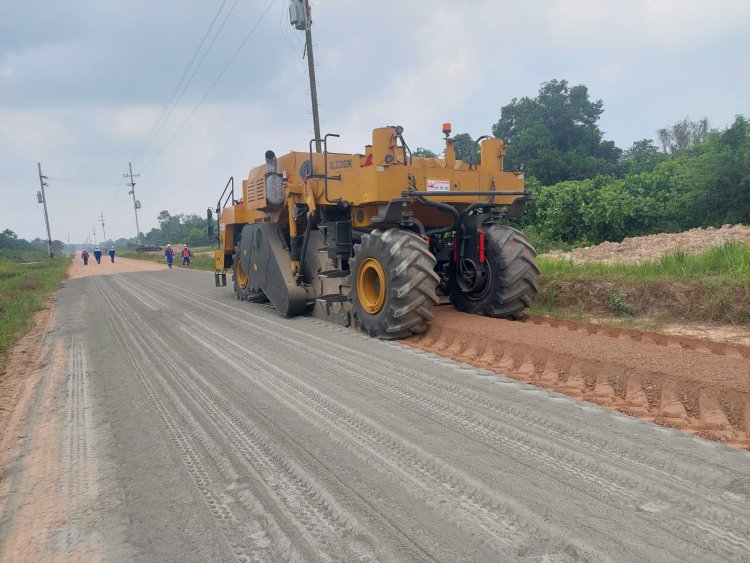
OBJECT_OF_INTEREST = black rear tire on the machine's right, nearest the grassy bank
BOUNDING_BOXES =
[450,225,539,320]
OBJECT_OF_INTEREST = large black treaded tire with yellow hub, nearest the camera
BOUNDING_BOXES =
[349,229,440,340]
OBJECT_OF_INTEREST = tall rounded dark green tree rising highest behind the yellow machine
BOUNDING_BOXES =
[492,80,622,185]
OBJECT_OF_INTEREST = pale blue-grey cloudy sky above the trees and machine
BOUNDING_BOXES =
[0,0,750,242]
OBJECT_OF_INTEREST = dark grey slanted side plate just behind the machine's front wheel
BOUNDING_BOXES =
[240,223,307,317]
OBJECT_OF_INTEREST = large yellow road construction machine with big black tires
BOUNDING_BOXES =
[209,123,539,339]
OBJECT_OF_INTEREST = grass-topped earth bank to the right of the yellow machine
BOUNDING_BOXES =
[531,242,750,324]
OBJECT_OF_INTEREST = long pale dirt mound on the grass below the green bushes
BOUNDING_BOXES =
[543,225,750,264]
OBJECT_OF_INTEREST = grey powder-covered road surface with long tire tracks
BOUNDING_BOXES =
[0,270,750,562]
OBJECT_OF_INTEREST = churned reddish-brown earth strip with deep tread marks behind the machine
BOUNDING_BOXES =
[405,307,750,449]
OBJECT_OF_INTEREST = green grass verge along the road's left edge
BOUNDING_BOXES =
[0,249,70,370]
